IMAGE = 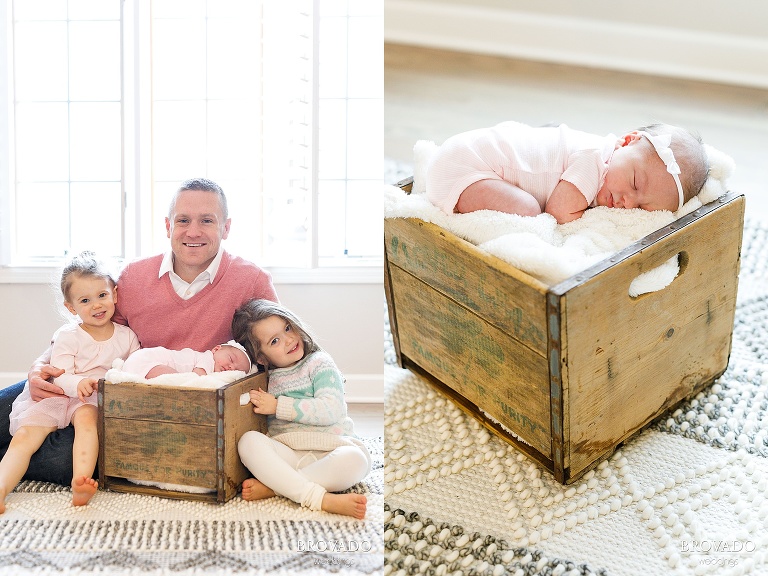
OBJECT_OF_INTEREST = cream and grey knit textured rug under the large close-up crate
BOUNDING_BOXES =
[384,161,768,576]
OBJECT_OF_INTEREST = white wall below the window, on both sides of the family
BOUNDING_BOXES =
[0,279,384,402]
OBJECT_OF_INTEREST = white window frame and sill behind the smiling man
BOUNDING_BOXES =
[0,0,383,284]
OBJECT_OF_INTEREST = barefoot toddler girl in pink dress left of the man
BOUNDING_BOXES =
[0,252,139,513]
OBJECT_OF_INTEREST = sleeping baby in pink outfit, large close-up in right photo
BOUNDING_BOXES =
[427,122,708,224]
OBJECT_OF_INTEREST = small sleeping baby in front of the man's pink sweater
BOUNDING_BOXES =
[123,340,251,378]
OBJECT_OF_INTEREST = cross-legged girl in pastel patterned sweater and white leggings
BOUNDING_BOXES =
[232,300,371,519]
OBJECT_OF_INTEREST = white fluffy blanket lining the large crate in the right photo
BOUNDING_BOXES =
[384,141,734,296]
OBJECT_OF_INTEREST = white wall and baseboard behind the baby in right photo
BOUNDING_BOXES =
[384,0,768,88]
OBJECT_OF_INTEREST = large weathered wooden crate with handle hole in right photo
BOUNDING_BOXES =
[384,181,744,484]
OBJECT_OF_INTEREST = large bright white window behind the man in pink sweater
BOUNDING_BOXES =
[0,0,383,280]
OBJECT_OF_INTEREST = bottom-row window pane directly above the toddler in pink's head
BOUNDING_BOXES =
[70,182,123,257]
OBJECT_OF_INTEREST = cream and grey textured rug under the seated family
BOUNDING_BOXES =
[0,437,384,576]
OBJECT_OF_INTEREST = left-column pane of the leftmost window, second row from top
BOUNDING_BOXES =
[13,22,68,101]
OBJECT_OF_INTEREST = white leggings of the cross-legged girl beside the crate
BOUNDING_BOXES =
[237,430,370,510]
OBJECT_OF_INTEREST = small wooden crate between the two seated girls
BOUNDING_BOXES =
[98,373,267,502]
